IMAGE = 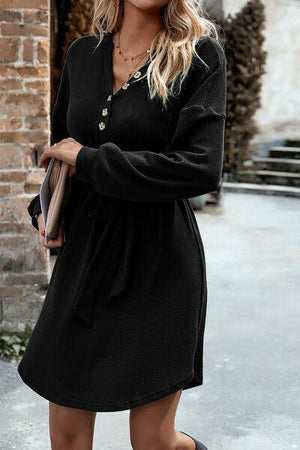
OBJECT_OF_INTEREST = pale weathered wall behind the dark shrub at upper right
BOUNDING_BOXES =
[223,0,300,142]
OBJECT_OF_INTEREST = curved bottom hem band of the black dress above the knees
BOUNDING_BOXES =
[18,367,202,412]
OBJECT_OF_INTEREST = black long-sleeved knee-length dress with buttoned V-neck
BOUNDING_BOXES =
[18,33,226,411]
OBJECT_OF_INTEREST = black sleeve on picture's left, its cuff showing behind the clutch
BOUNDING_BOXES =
[27,46,70,230]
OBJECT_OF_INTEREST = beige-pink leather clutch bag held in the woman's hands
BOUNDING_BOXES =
[40,157,72,243]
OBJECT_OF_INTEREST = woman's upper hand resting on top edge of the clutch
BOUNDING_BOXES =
[39,137,83,170]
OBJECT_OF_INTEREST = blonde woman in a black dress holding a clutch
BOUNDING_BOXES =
[18,0,226,450]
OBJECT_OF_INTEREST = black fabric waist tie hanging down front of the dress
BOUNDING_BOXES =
[73,195,153,327]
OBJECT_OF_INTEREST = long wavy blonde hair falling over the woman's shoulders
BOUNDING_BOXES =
[92,0,219,107]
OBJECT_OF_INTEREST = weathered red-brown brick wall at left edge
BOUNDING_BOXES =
[0,0,50,330]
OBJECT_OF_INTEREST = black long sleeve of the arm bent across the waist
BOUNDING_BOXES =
[75,40,227,202]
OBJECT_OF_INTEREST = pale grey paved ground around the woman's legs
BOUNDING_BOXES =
[0,192,300,450]
